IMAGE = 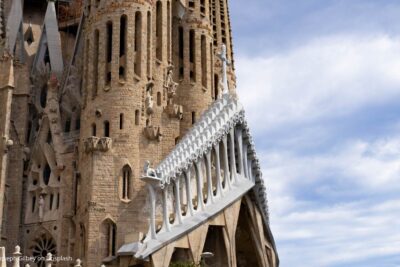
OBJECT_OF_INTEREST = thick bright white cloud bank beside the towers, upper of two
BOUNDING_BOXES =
[236,35,400,131]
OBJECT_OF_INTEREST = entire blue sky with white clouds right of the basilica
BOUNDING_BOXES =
[230,0,400,267]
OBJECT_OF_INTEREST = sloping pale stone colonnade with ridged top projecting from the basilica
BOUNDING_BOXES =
[135,96,267,259]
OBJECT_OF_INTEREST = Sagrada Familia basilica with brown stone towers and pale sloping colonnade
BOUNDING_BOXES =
[0,0,279,267]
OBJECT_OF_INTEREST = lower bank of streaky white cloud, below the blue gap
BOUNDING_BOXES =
[261,138,400,267]
